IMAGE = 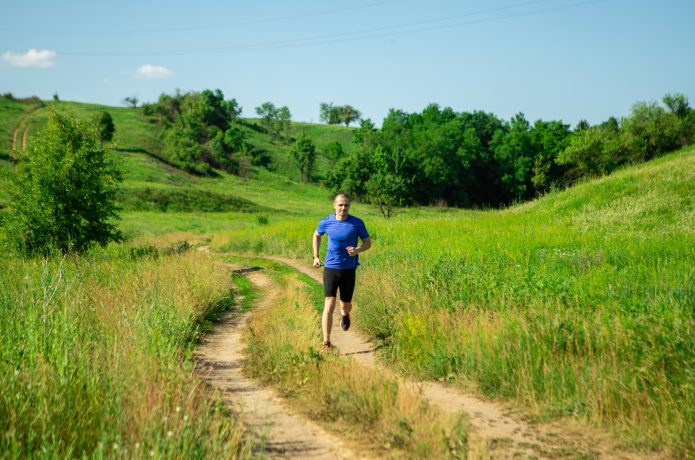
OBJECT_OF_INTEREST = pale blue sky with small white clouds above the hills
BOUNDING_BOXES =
[0,0,695,125]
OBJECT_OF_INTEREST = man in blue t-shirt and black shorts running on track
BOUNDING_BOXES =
[312,193,372,348]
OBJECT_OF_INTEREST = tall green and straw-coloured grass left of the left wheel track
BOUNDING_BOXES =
[0,240,251,458]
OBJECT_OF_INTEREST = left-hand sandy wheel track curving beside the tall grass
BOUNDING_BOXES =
[196,271,364,459]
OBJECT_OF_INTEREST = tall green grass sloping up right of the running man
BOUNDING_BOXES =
[213,151,695,455]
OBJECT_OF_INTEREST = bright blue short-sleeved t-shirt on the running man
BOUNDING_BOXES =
[316,214,369,270]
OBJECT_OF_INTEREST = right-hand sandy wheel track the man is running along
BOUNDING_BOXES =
[267,257,659,459]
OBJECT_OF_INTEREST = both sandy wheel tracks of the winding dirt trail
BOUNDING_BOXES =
[196,253,665,459]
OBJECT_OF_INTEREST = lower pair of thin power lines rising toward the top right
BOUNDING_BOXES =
[59,0,609,56]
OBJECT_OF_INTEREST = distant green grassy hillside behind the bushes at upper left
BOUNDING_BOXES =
[0,98,352,212]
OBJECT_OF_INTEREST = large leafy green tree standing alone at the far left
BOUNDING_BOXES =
[5,111,121,255]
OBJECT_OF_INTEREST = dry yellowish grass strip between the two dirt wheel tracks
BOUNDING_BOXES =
[239,262,468,458]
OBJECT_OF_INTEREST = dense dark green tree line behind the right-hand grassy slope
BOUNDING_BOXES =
[327,94,695,216]
